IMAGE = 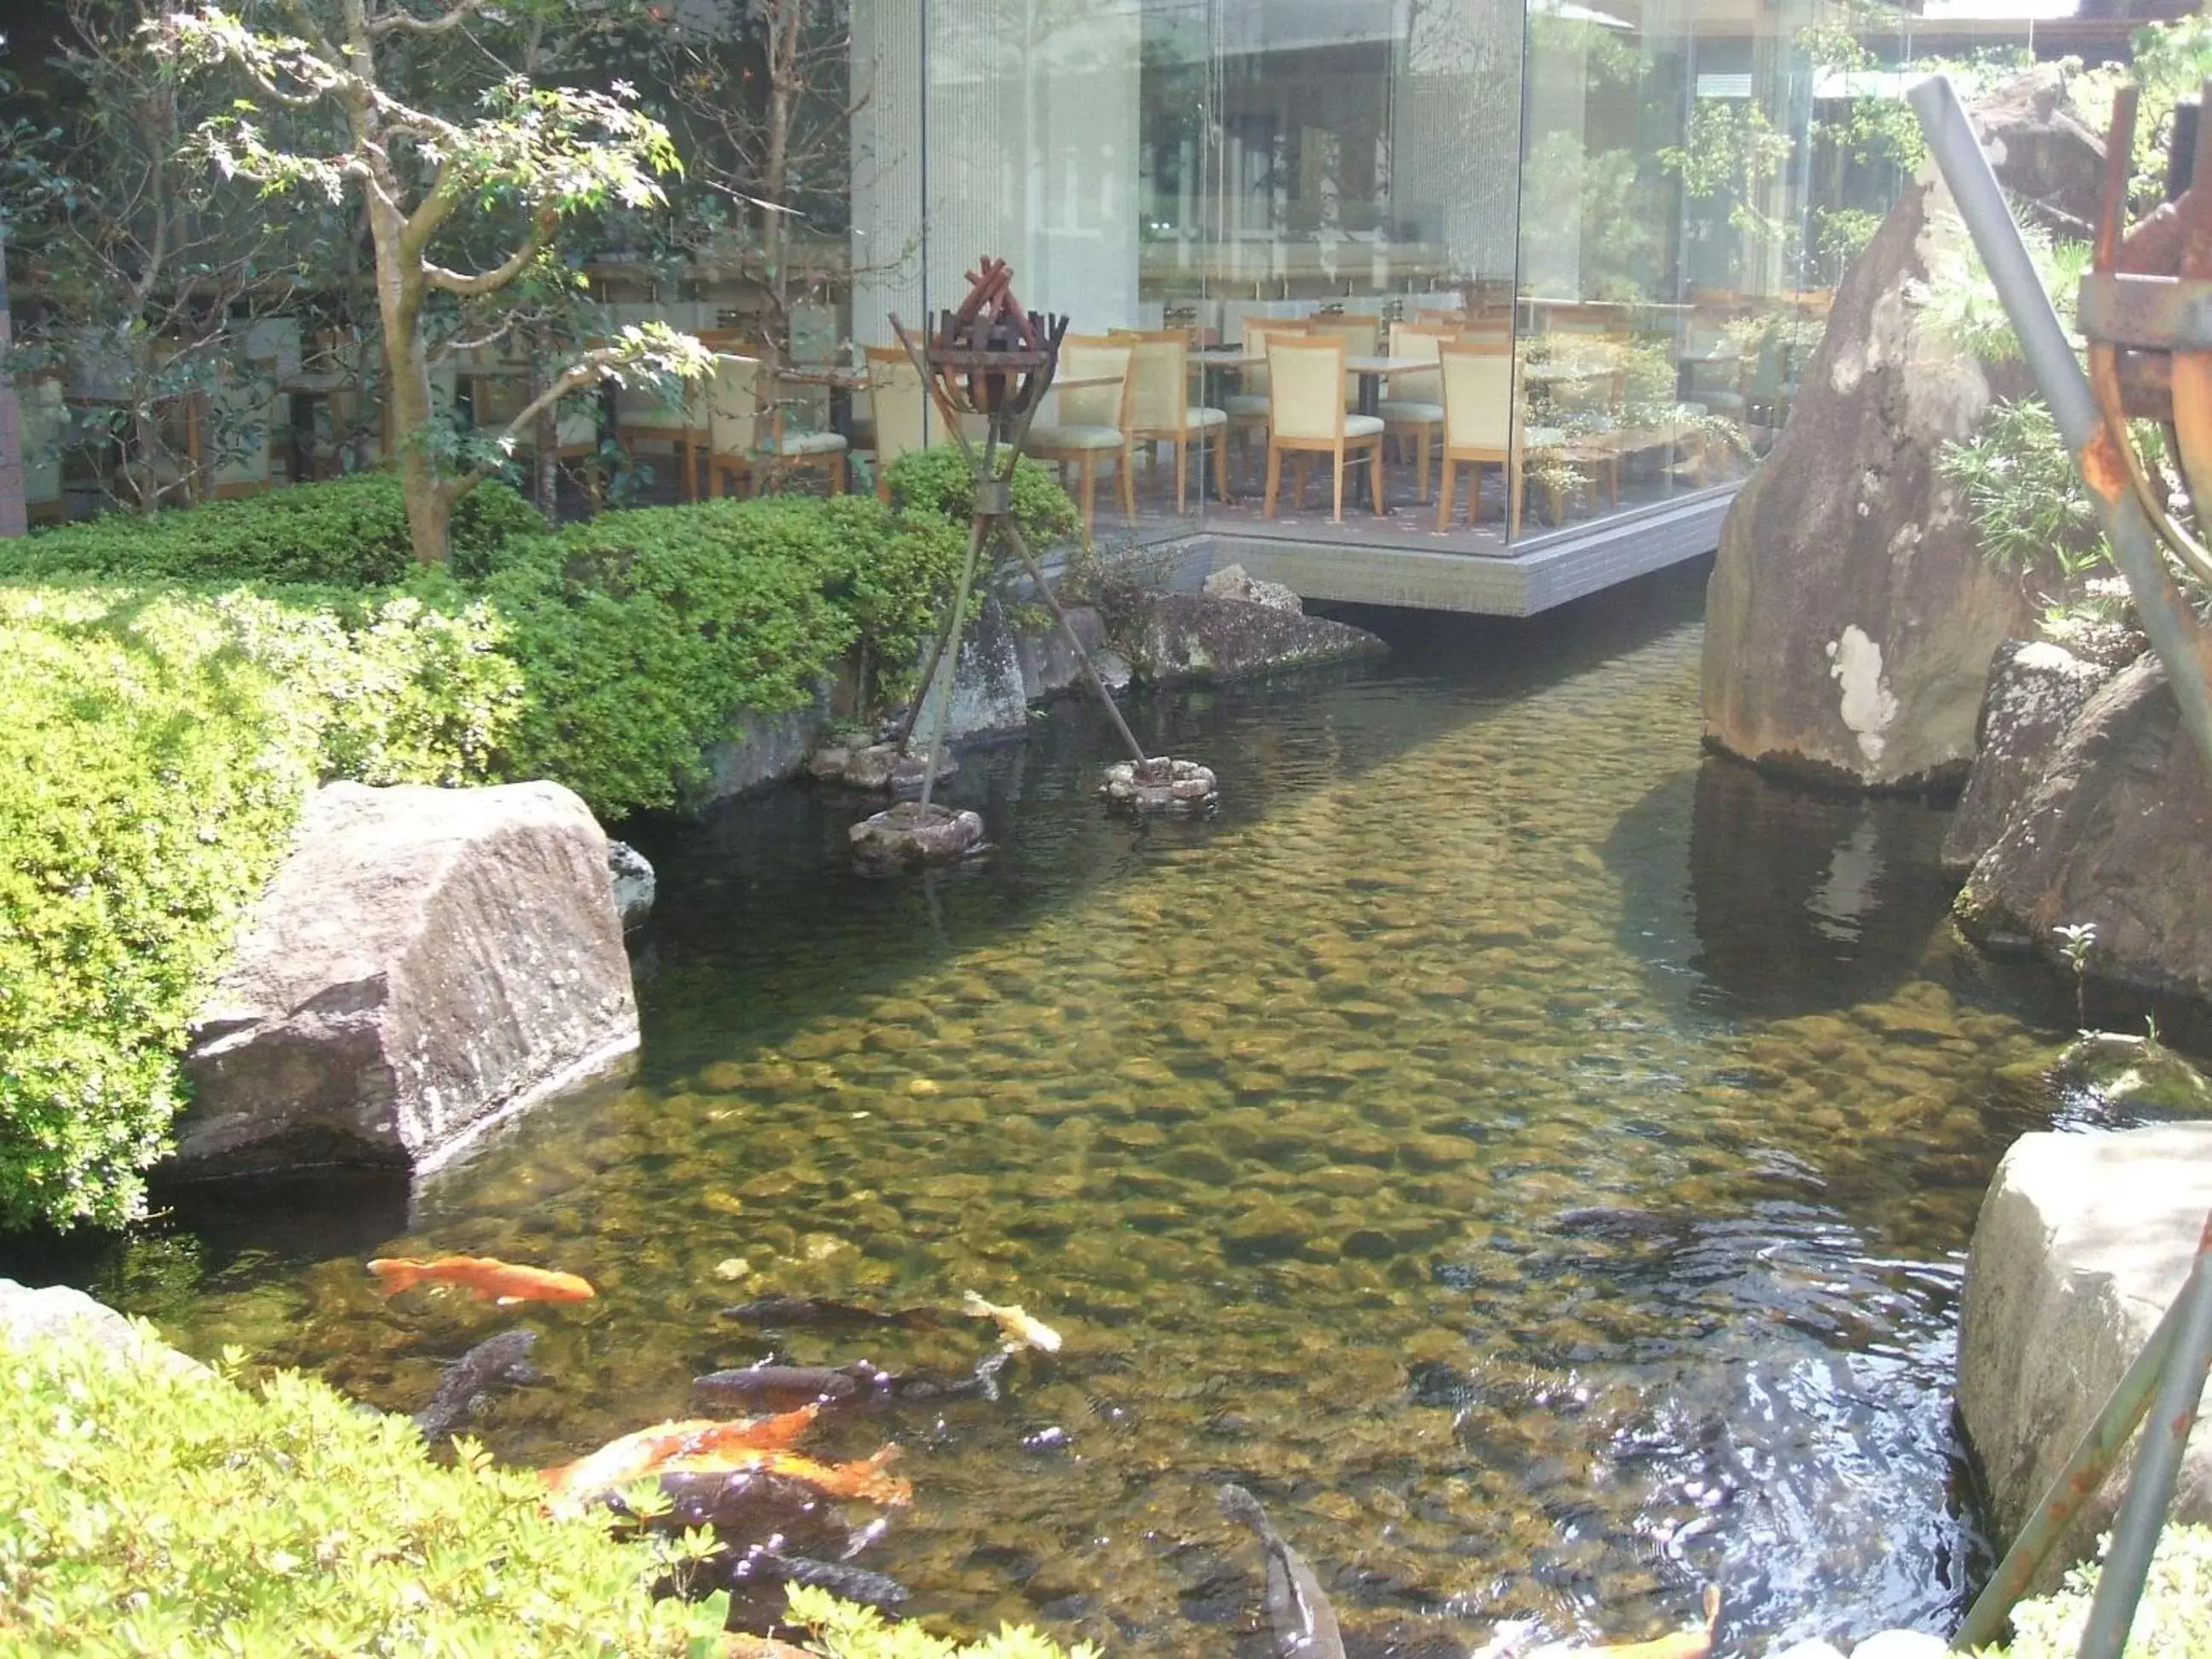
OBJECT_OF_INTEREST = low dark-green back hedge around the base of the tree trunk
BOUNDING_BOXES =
[0,474,546,586]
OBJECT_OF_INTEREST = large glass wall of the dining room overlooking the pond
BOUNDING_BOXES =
[852,0,2026,553]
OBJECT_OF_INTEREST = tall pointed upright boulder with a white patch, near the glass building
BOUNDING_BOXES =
[1703,83,2037,789]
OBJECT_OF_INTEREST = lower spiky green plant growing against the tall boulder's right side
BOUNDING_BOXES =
[1936,399,2108,575]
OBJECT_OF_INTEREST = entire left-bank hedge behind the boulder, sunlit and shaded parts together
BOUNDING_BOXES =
[0,478,981,1228]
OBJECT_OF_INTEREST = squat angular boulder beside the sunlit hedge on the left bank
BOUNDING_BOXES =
[166,783,637,1179]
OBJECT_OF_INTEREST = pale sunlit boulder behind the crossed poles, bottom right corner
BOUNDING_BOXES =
[1958,1124,2212,1591]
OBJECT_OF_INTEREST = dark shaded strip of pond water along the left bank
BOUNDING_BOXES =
[624,560,1705,1075]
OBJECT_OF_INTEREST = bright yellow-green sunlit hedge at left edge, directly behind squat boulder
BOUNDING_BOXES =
[0,582,520,1228]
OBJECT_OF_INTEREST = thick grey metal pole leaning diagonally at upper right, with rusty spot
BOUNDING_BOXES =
[1906,75,2212,770]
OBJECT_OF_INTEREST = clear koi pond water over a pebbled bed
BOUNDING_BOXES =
[17,571,2073,1655]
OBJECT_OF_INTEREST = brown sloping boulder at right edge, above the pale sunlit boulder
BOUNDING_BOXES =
[1955,655,2212,1000]
